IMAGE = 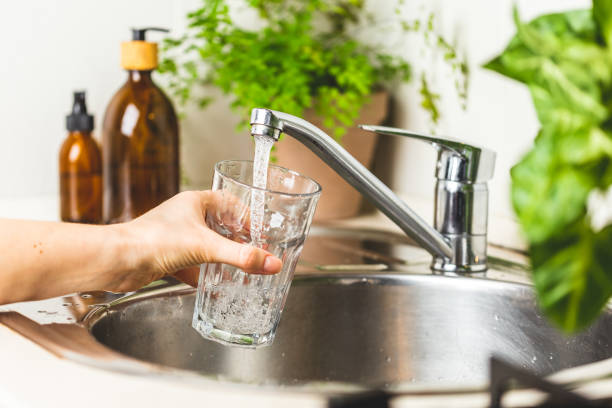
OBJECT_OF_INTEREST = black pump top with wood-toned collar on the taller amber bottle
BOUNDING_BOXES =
[121,27,169,71]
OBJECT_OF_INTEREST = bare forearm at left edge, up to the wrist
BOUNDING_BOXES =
[0,219,139,304]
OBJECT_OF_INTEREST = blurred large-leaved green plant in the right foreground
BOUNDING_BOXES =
[486,0,612,332]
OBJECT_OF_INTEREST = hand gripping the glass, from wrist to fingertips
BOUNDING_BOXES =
[104,191,282,292]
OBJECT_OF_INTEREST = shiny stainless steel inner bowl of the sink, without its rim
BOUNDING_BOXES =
[89,273,612,388]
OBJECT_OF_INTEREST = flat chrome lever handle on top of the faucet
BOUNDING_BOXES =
[359,125,495,183]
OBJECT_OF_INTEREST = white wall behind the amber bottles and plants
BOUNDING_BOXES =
[0,0,590,245]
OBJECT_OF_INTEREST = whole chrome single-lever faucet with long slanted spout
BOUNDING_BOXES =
[251,108,495,273]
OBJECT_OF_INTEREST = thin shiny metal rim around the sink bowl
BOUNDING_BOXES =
[0,271,612,398]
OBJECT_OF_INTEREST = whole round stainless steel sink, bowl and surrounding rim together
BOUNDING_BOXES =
[0,228,612,396]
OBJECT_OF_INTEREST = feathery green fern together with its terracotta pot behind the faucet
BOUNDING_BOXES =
[160,0,467,220]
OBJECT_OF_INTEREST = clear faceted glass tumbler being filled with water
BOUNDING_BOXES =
[192,160,321,348]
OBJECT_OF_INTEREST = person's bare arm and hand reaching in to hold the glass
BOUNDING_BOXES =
[0,191,282,304]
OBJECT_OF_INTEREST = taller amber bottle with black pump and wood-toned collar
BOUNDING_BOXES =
[102,28,179,223]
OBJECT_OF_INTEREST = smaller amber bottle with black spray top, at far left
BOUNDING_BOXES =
[59,92,102,224]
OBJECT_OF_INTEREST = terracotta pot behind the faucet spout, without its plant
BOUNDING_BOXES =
[276,92,389,221]
